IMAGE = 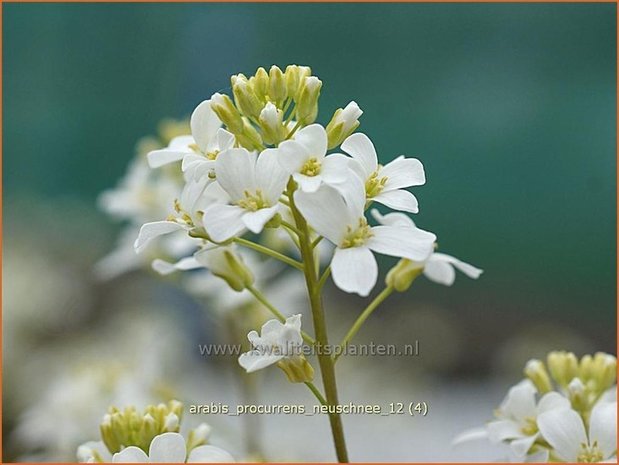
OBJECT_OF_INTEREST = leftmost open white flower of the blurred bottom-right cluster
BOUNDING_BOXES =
[487,379,570,458]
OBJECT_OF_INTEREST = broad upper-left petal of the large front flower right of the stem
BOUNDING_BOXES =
[294,185,358,245]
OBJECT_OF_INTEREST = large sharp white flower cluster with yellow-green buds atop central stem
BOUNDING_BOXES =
[135,65,481,296]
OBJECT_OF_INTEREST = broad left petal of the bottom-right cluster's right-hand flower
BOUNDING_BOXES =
[537,409,587,462]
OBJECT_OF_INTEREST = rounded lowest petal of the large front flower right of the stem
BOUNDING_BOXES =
[331,247,378,297]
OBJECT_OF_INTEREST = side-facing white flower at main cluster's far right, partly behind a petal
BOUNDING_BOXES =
[371,209,483,286]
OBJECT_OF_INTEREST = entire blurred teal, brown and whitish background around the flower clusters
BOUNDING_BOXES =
[3,4,616,461]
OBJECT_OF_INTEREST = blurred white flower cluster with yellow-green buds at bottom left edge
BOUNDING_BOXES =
[77,401,234,463]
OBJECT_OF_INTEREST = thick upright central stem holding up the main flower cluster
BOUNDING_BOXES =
[288,180,348,462]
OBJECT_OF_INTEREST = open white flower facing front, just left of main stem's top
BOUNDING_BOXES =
[203,148,288,242]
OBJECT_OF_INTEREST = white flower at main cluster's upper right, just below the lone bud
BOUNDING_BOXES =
[341,133,426,213]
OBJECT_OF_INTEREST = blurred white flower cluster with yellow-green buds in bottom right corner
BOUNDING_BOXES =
[455,352,617,463]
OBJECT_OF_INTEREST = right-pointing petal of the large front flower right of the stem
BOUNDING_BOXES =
[366,226,436,262]
